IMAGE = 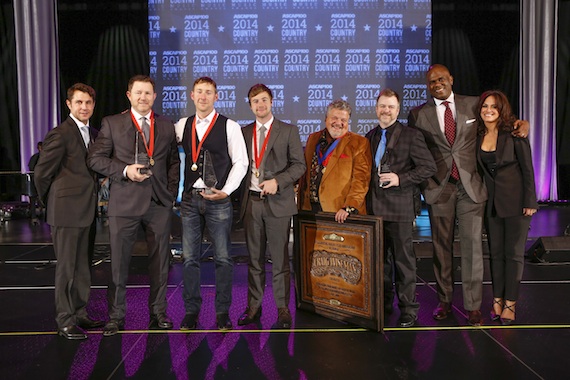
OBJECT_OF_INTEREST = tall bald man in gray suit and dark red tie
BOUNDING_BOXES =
[408,64,528,326]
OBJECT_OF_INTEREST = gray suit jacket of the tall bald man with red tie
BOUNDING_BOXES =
[408,94,487,204]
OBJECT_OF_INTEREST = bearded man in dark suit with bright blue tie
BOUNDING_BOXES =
[366,89,436,327]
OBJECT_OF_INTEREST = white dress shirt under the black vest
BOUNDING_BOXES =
[174,109,248,195]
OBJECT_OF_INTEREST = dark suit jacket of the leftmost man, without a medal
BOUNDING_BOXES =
[34,117,97,227]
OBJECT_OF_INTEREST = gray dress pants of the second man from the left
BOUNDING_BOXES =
[107,201,172,320]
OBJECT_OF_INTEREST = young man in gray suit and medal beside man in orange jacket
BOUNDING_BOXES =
[238,84,306,328]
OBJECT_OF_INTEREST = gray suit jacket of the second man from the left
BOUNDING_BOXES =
[87,112,180,216]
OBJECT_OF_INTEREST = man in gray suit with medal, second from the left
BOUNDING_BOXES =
[88,75,180,336]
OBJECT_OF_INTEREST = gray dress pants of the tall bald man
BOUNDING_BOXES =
[428,183,485,311]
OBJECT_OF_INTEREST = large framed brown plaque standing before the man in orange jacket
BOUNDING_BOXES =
[293,212,384,332]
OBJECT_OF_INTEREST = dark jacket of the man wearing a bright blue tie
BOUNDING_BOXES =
[366,122,437,222]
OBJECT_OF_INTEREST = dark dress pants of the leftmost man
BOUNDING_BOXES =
[51,226,91,328]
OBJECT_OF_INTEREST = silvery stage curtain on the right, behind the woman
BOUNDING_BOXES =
[520,0,558,200]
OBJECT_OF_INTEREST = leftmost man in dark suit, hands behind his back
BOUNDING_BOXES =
[33,83,103,339]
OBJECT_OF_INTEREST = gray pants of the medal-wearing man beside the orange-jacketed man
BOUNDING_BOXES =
[244,196,291,308]
